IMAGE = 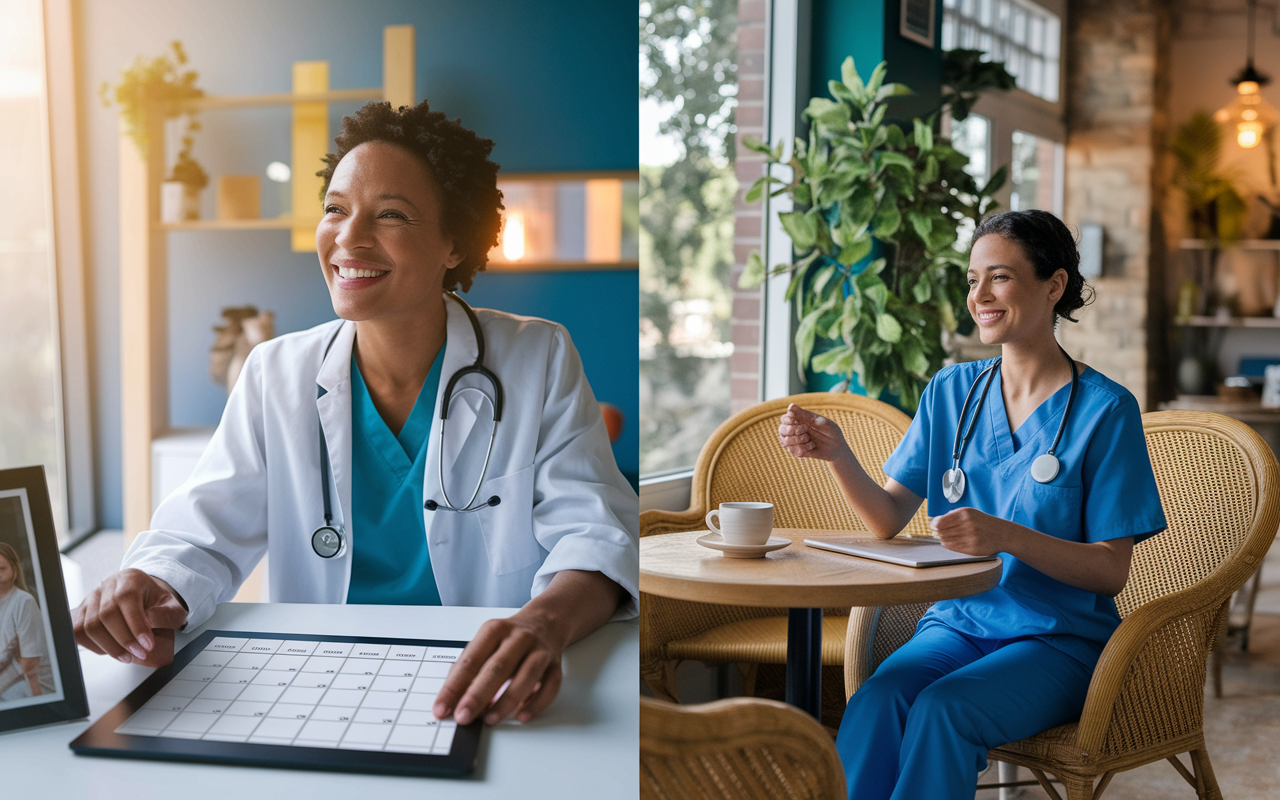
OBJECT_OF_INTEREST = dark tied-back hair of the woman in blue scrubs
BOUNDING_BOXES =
[969,209,1093,323]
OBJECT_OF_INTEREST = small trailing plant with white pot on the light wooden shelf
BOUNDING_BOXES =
[99,40,209,223]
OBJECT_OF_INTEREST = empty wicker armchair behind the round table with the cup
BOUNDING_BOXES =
[640,393,928,701]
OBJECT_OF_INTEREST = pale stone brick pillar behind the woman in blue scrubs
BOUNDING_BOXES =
[1060,0,1169,410]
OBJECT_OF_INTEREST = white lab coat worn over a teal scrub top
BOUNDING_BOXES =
[123,298,640,627]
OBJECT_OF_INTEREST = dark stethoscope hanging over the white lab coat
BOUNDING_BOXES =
[311,292,502,558]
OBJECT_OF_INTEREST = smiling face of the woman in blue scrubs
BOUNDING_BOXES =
[969,234,1066,344]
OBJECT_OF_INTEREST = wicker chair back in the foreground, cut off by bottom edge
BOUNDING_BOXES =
[640,698,845,800]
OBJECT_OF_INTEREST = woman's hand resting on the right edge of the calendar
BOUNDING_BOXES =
[431,570,626,724]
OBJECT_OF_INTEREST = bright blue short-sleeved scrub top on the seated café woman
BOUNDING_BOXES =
[884,358,1167,666]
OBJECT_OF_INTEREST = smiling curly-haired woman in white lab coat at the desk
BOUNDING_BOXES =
[76,101,639,724]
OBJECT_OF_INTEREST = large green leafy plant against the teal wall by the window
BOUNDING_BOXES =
[740,58,1006,411]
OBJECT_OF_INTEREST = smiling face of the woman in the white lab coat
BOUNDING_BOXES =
[316,142,462,321]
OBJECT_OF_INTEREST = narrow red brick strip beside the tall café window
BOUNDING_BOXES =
[730,0,765,413]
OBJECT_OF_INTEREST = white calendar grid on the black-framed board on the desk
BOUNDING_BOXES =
[116,636,462,755]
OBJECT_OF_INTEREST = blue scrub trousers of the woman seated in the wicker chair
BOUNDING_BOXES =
[836,622,1094,800]
